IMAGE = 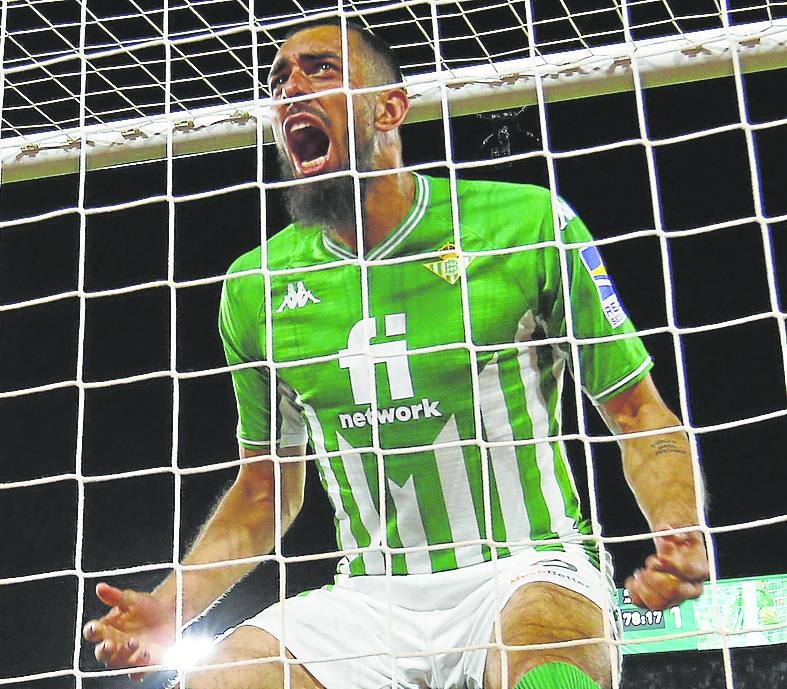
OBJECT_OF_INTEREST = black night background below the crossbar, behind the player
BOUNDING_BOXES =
[0,1,787,689]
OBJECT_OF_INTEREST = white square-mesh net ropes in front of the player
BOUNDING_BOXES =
[0,2,787,689]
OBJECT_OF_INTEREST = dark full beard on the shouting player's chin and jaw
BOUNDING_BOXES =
[276,134,374,230]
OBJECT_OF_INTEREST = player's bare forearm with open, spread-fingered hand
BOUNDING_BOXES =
[84,440,305,667]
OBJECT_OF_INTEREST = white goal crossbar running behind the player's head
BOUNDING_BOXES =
[0,20,787,183]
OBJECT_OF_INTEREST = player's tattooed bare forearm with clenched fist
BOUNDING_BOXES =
[602,376,708,609]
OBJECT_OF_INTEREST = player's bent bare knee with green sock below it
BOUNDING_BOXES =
[484,582,612,689]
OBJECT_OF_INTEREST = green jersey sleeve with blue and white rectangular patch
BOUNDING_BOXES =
[545,199,653,404]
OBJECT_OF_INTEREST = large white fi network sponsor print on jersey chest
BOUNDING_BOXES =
[339,313,442,428]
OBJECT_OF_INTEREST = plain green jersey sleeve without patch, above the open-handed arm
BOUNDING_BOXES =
[219,260,307,450]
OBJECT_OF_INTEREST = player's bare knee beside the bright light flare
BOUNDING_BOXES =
[186,626,323,689]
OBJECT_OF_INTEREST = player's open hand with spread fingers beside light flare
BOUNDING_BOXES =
[83,582,175,680]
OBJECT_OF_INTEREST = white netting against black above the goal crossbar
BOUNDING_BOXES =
[3,0,783,137]
